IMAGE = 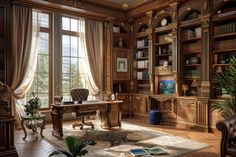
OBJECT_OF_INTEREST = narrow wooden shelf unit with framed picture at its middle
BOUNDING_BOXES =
[112,21,131,93]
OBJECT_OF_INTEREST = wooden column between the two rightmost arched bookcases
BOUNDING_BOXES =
[200,15,210,97]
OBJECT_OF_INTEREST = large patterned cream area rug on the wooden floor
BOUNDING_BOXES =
[44,121,209,157]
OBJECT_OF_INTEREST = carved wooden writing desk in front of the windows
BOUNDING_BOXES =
[51,101,122,137]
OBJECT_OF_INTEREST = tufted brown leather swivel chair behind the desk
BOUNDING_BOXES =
[70,88,96,130]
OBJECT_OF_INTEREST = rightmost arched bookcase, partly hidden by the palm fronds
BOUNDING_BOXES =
[211,3,236,98]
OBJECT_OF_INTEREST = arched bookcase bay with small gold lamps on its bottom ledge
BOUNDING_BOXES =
[179,11,202,96]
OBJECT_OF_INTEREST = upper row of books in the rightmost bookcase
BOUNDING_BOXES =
[214,22,236,35]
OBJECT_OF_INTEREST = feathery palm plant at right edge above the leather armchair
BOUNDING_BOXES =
[211,57,236,118]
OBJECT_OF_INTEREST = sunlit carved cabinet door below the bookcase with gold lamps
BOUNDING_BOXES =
[177,99,197,123]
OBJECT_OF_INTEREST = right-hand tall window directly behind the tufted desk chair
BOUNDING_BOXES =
[62,17,86,101]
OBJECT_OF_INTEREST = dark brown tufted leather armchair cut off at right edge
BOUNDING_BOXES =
[216,114,236,157]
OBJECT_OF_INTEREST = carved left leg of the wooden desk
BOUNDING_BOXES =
[51,106,63,138]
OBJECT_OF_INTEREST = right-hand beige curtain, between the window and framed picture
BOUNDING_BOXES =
[85,19,104,95]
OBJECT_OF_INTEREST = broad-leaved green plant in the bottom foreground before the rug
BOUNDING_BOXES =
[49,136,96,157]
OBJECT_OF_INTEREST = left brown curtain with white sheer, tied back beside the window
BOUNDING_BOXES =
[10,5,39,116]
